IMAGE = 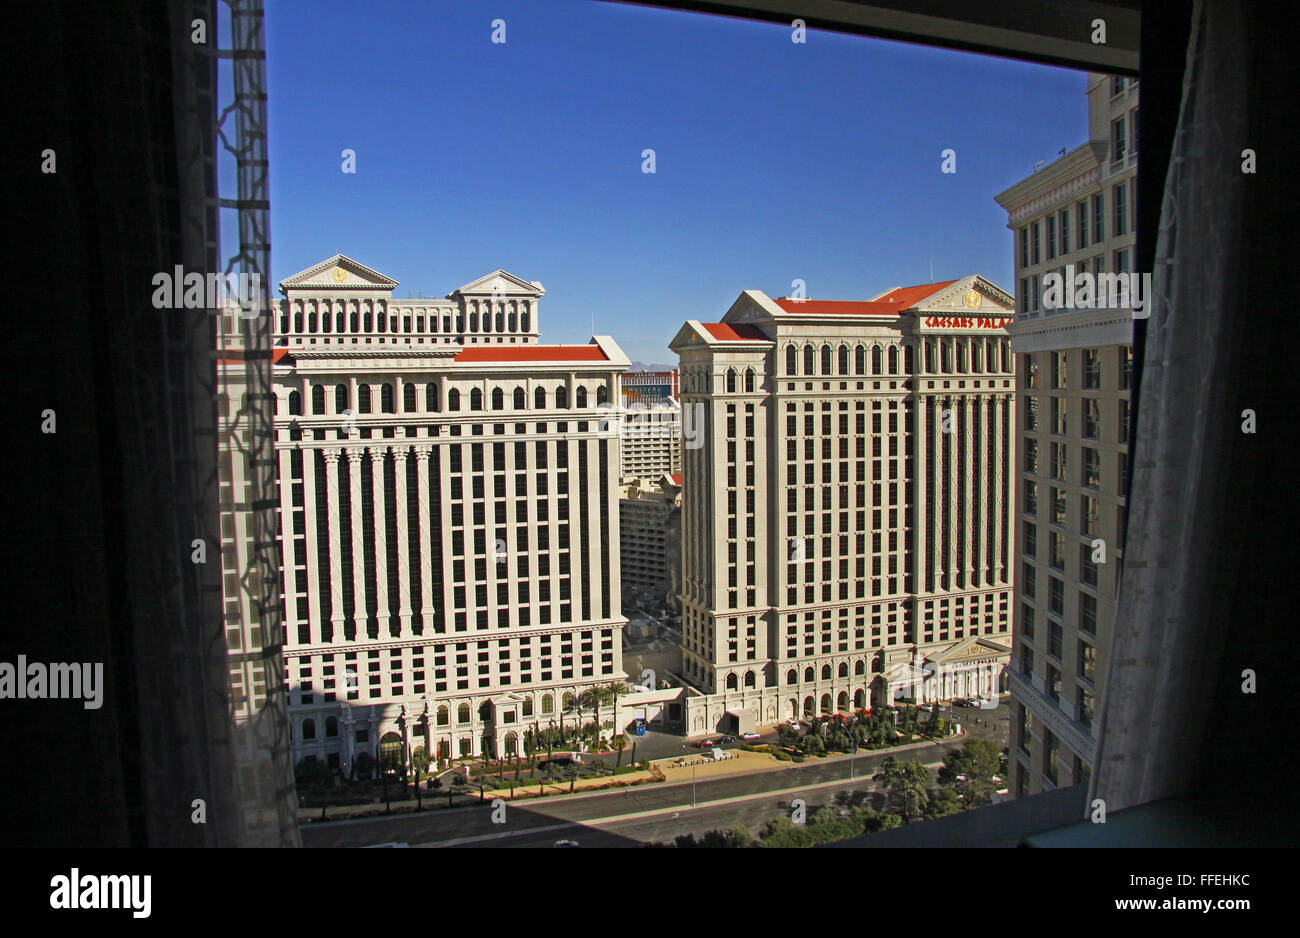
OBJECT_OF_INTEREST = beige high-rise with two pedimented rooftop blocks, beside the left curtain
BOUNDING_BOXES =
[266,255,628,772]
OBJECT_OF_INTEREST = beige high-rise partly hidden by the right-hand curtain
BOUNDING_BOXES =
[997,74,1147,796]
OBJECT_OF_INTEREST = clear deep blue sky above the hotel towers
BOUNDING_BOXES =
[267,0,1087,364]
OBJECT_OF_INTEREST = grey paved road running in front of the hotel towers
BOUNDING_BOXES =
[302,703,1006,847]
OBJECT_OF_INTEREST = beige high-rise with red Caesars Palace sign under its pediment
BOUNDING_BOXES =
[671,277,1015,733]
